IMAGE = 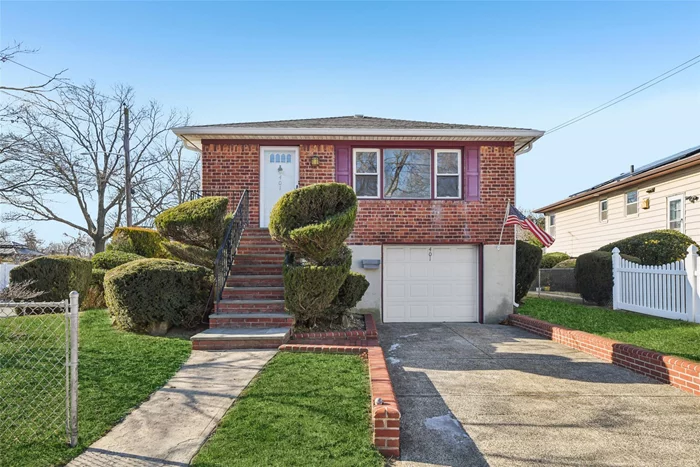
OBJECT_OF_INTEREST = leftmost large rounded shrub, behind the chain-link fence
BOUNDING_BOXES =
[10,255,92,303]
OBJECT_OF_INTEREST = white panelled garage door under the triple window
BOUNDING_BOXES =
[383,245,479,322]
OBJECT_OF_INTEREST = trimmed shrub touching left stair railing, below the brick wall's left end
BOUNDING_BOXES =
[155,196,230,249]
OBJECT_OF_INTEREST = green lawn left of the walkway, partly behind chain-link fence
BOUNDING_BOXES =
[0,310,191,467]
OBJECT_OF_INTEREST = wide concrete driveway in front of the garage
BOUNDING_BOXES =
[379,324,700,466]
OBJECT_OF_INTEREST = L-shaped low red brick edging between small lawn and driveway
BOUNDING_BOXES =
[279,342,401,457]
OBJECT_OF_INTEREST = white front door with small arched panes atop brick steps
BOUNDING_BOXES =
[260,146,299,227]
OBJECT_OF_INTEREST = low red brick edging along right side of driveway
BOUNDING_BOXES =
[508,314,700,396]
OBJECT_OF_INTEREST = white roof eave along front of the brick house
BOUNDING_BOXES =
[172,126,544,153]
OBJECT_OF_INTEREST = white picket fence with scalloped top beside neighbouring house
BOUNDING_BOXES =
[613,245,700,322]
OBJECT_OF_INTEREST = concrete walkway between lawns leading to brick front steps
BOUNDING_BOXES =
[68,350,277,467]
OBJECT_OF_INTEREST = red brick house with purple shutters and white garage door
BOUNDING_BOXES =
[174,115,543,322]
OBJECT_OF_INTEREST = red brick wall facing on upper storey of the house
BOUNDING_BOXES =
[202,141,515,245]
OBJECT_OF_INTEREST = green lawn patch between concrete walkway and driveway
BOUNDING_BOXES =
[192,352,384,467]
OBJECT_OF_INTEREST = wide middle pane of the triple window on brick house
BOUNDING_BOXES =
[383,149,431,199]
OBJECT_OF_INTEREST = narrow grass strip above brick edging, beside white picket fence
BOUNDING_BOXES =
[518,297,700,361]
